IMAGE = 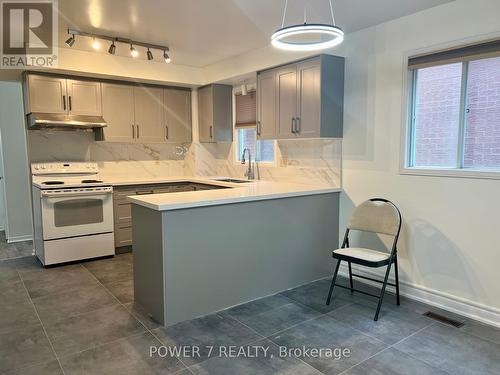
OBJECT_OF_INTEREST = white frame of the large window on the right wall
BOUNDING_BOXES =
[399,37,500,180]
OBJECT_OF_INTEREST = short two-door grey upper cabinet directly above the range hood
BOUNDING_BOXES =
[26,74,102,116]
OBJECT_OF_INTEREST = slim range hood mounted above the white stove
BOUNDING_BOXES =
[27,112,107,129]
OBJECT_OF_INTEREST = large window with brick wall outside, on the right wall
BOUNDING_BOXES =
[403,41,500,178]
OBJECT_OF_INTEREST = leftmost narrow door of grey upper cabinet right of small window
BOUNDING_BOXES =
[257,71,276,139]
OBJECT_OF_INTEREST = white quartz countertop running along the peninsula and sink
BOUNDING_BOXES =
[127,177,341,211]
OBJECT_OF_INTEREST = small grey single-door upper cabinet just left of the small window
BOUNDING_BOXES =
[198,84,233,142]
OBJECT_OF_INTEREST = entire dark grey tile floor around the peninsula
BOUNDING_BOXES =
[0,254,500,375]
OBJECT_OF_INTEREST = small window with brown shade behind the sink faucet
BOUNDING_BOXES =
[234,91,275,163]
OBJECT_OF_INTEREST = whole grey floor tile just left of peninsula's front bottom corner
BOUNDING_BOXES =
[44,305,145,356]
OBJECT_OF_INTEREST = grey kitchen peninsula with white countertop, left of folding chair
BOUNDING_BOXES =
[128,179,340,326]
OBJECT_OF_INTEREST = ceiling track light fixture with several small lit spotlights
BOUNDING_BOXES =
[66,28,172,64]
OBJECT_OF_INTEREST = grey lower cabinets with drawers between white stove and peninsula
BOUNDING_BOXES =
[113,182,226,253]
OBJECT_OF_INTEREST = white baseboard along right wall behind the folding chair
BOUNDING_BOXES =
[339,262,500,328]
